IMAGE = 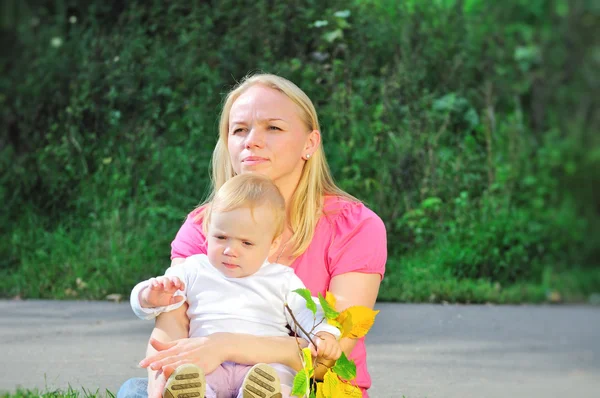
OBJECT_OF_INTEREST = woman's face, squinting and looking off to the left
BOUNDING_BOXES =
[227,84,320,189]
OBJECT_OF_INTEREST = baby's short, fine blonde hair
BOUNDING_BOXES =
[202,173,285,239]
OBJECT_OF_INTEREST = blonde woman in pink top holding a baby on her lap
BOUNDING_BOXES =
[123,74,387,397]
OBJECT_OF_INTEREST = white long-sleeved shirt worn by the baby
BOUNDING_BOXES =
[130,254,340,338]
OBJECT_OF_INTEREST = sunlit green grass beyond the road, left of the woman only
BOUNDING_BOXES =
[0,205,183,299]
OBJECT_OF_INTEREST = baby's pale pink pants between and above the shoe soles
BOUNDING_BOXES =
[206,362,296,398]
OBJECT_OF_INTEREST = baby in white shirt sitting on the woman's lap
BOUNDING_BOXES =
[131,173,341,398]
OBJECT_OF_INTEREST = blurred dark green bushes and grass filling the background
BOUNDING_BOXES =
[0,0,600,303]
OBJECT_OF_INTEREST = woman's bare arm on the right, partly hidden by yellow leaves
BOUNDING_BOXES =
[315,272,381,380]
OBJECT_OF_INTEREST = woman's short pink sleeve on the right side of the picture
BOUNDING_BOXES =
[327,202,387,278]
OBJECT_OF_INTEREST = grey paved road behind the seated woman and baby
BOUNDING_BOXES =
[0,301,600,398]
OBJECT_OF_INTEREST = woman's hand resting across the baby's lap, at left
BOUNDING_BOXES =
[140,333,228,378]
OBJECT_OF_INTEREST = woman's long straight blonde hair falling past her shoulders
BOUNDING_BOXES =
[199,74,358,257]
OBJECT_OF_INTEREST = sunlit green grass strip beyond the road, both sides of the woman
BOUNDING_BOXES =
[0,205,600,304]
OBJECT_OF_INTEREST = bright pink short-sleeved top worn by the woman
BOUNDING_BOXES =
[171,196,387,397]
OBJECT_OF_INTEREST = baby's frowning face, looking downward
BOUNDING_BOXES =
[207,206,279,278]
